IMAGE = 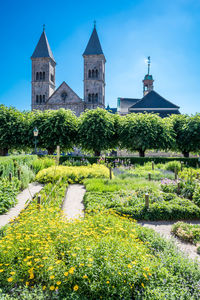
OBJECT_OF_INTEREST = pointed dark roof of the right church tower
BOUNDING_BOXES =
[83,26,103,55]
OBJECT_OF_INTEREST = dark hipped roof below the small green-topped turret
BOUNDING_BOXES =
[131,91,179,109]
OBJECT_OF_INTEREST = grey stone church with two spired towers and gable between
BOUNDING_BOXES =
[31,26,106,116]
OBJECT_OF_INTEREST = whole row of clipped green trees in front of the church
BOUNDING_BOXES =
[0,105,200,157]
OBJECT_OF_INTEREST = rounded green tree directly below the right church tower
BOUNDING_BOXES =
[78,108,119,156]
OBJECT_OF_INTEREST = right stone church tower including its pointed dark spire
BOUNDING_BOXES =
[83,25,106,109]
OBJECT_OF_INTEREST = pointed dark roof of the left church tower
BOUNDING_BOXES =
[31,30,55,62]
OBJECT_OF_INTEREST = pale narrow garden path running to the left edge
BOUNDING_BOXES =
[0,182,43,228]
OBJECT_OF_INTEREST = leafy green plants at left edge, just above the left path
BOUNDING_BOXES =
[0,178,20,215]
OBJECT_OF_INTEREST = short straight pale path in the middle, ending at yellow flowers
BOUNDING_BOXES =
[63,184,86,219]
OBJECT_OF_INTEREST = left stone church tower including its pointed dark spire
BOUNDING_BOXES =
[31,29,56,110]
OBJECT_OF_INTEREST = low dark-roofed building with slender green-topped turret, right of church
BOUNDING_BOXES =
[117,57,180,118]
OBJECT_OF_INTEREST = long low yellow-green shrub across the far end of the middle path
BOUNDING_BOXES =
[36,165,109,183]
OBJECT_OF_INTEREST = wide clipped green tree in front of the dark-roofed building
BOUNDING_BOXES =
[120,113,174,157]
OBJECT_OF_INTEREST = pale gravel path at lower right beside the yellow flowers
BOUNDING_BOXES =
[138,221,200,263]
